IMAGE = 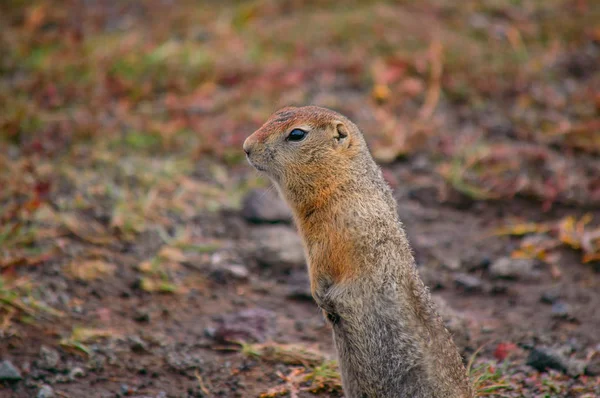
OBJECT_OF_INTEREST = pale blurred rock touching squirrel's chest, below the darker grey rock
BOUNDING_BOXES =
[253,226,305,270]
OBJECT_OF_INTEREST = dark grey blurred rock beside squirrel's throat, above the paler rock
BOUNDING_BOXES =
[242,189,292,223]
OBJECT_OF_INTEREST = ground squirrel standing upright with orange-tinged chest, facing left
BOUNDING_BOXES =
[244,106,473,398]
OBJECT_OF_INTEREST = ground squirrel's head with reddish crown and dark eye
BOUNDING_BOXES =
[244,106,366,195]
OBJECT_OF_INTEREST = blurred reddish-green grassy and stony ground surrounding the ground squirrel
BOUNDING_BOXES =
[0,0,600,397]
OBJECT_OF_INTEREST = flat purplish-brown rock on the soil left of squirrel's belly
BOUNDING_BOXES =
[215,308,276,342]
